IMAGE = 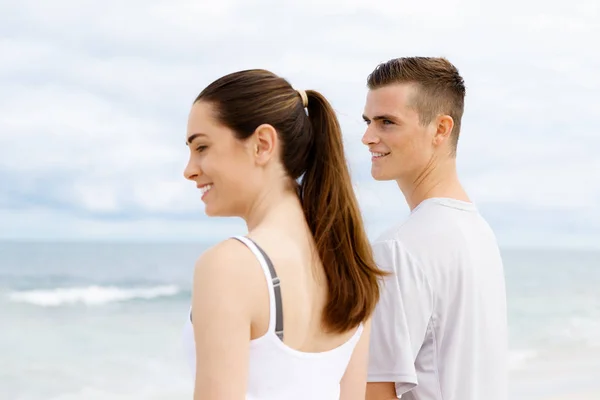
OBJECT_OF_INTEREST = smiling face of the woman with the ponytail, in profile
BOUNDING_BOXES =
[184,101,257,216]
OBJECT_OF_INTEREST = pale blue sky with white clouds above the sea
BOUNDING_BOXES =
[0,0,600,248]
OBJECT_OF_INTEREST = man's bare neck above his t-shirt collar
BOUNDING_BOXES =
[397,158,470,211]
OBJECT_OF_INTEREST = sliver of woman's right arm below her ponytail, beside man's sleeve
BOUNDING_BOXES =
[340,320,371,400]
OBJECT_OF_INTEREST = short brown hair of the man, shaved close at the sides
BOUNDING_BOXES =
[367,57,466,155]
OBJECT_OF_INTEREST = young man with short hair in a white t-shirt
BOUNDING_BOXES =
[363,57,507,400]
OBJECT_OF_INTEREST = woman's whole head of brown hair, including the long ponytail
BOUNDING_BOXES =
[196,70,384,332]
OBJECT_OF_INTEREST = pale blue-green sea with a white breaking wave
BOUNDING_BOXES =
[0,242,600,400]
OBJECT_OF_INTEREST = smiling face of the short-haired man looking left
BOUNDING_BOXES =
[362,83,436,183]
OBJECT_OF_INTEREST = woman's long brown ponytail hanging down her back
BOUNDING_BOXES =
[301,90,385,332]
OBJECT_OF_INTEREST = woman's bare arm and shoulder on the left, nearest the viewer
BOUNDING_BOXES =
[192,241,256,400]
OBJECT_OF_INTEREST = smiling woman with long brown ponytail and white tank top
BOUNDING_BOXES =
[185,70,383,400]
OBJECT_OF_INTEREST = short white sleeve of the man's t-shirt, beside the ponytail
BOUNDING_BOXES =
[368,240,433,395]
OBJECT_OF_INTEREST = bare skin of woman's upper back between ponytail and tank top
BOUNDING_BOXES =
[241,206,356,353]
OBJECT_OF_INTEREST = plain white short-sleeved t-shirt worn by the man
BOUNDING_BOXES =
[368,198,508,400]
